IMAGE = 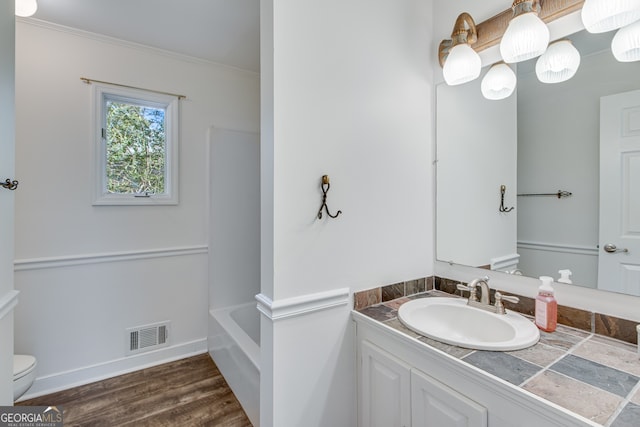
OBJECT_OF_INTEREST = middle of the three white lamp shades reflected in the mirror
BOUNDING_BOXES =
[536,40,580,83]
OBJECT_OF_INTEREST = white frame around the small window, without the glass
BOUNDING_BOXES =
[92,83,180,206]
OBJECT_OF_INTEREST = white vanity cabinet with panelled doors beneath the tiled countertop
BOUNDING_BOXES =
[353,312,599,427]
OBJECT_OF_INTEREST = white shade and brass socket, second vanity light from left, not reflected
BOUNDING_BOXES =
[500,0,552,64]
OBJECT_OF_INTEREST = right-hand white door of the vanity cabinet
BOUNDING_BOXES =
[411,369,487,427]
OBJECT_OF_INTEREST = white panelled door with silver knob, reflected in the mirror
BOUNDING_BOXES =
[598,90,640,296]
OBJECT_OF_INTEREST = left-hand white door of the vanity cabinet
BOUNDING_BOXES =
[358,341,411,427]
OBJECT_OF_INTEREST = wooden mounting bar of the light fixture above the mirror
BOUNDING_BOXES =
[471,0,584,52]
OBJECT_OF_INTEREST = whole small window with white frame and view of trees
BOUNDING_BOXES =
[94,83,179,205]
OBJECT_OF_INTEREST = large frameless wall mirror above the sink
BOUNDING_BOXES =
[436,24,640,296]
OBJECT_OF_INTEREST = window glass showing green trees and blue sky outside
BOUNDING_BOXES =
[105,100,166,194]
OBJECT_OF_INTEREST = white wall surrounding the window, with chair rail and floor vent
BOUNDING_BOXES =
[15,20,259,400]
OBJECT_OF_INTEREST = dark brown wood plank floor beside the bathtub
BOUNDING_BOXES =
[17,353,251,427]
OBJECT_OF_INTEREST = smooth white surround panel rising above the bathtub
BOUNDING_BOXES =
[207,126,260,310]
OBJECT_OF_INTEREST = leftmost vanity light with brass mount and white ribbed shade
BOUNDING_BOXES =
[438,12,482,86]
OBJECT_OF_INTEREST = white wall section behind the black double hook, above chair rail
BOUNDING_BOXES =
[265,1,433,299]
